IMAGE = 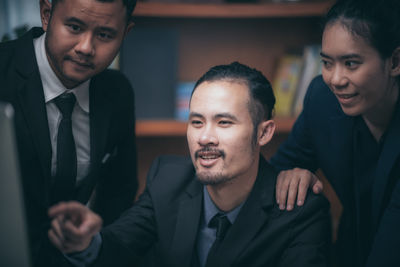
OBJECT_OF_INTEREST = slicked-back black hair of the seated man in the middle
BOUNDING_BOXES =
[192,62,275,127]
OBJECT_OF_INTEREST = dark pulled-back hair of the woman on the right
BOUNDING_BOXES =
[324,0,400,59]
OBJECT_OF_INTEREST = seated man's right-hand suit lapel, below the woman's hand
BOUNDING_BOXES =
[208,157,276,267]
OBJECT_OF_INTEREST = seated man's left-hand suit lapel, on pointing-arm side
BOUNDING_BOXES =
[169,177,203,266]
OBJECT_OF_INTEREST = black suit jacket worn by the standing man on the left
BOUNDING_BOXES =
[0,28,137,267]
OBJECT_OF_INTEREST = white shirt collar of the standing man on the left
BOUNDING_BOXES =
[33,33,90,113]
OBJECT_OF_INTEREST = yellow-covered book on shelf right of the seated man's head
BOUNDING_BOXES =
[272,54,302,117]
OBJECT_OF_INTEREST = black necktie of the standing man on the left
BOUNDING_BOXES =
[53,93,76,203]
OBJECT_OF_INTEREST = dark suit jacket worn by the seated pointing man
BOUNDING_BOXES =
[97,156,330,267]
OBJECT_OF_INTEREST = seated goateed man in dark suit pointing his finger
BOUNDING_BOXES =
[49,62,330,267]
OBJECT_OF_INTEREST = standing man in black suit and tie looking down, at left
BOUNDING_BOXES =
[0,0,137,266]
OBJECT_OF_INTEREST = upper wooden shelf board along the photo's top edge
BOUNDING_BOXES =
[133,0,333,18]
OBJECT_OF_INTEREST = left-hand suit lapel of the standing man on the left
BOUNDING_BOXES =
[15,28,52,205]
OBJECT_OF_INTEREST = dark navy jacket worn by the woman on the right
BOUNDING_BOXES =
[271,76,400,266]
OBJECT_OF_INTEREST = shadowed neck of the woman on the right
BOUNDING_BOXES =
[362,84,399,142]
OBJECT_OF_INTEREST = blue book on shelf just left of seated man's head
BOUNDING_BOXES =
[175,82,196,121]
